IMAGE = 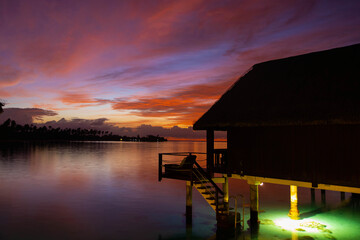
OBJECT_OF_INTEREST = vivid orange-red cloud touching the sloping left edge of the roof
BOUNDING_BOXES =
[111,80,233,125]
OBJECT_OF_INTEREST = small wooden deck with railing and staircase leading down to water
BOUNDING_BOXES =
[159,153,240,229]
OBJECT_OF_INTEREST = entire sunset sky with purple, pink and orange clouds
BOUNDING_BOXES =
[0,0,360,139]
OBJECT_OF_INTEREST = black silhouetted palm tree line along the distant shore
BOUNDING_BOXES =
[0,119,167,142]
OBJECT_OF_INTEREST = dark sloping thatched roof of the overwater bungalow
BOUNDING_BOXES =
[194,44,360,130]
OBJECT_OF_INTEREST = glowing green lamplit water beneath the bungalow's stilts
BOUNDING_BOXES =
[225,184,360,240]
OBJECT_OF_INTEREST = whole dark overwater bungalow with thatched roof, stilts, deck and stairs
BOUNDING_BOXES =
[159,44,360,231]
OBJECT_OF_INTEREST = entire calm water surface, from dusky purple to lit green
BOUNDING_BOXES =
[0,142,360,239]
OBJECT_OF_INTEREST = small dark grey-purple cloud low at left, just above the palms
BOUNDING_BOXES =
[0,108,57,125]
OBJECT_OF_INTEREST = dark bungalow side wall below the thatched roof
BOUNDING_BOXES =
[228,125,360,187]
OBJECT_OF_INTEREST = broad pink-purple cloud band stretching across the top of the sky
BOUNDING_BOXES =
[1,0,359,77]
